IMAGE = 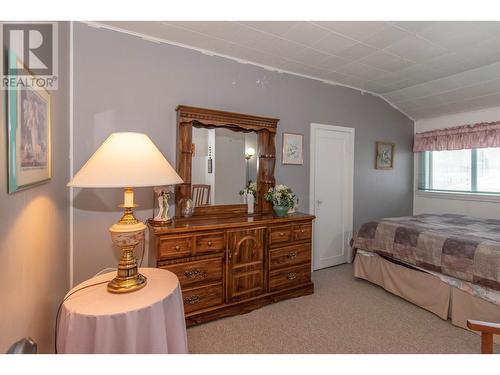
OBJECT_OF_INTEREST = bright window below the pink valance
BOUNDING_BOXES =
[419,148,500,194]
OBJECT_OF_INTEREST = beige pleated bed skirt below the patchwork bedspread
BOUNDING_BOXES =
[354,252,500,344]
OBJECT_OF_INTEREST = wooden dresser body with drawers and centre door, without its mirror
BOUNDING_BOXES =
[149,213,314,326]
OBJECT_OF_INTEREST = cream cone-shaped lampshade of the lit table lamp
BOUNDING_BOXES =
[68,133,183,188]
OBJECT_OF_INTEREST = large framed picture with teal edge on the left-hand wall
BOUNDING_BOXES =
[7,62,52,193]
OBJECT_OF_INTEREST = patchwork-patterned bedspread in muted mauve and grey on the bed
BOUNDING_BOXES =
[353,214,500,291]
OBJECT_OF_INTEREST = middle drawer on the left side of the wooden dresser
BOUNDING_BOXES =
[161,258,222,288]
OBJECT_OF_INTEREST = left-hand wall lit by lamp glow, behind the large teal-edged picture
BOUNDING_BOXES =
[0,22,69,353]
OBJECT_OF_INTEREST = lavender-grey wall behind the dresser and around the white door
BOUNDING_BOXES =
[73,23,413,282]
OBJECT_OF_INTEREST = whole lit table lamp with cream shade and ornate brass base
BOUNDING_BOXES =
[68,133,183,293]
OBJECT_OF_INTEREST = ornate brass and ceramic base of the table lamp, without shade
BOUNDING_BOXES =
[108,201,147,293]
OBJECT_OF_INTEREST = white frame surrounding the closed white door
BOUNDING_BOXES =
[309,123,355,271]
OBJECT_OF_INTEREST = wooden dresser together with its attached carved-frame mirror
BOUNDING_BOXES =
[149,105,314,325]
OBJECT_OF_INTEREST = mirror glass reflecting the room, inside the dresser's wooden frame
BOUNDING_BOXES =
[191,127,259,206]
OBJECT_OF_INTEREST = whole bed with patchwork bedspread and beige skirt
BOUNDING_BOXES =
[353,214,500,343]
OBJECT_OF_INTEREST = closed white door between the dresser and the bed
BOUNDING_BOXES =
[309,124,354,270]
